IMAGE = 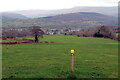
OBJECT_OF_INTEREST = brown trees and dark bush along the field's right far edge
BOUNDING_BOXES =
[69,26,119,40]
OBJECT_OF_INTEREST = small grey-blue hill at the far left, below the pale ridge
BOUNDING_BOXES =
[1,12,28,22]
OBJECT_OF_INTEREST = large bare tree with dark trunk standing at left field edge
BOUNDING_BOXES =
[31,26,44,43]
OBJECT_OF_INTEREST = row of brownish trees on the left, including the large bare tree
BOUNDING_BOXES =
[2,26,44,43]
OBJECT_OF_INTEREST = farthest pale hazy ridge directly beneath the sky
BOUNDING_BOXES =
[15,6,118,18]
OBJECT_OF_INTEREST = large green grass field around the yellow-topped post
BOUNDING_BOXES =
[2,35,118,78]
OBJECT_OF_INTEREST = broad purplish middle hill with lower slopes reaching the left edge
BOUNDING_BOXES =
[3,12,118,28]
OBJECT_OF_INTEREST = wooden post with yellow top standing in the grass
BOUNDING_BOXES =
[70,49,75,77]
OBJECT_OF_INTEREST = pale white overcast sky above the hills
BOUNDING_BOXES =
[0,0,119,12]
